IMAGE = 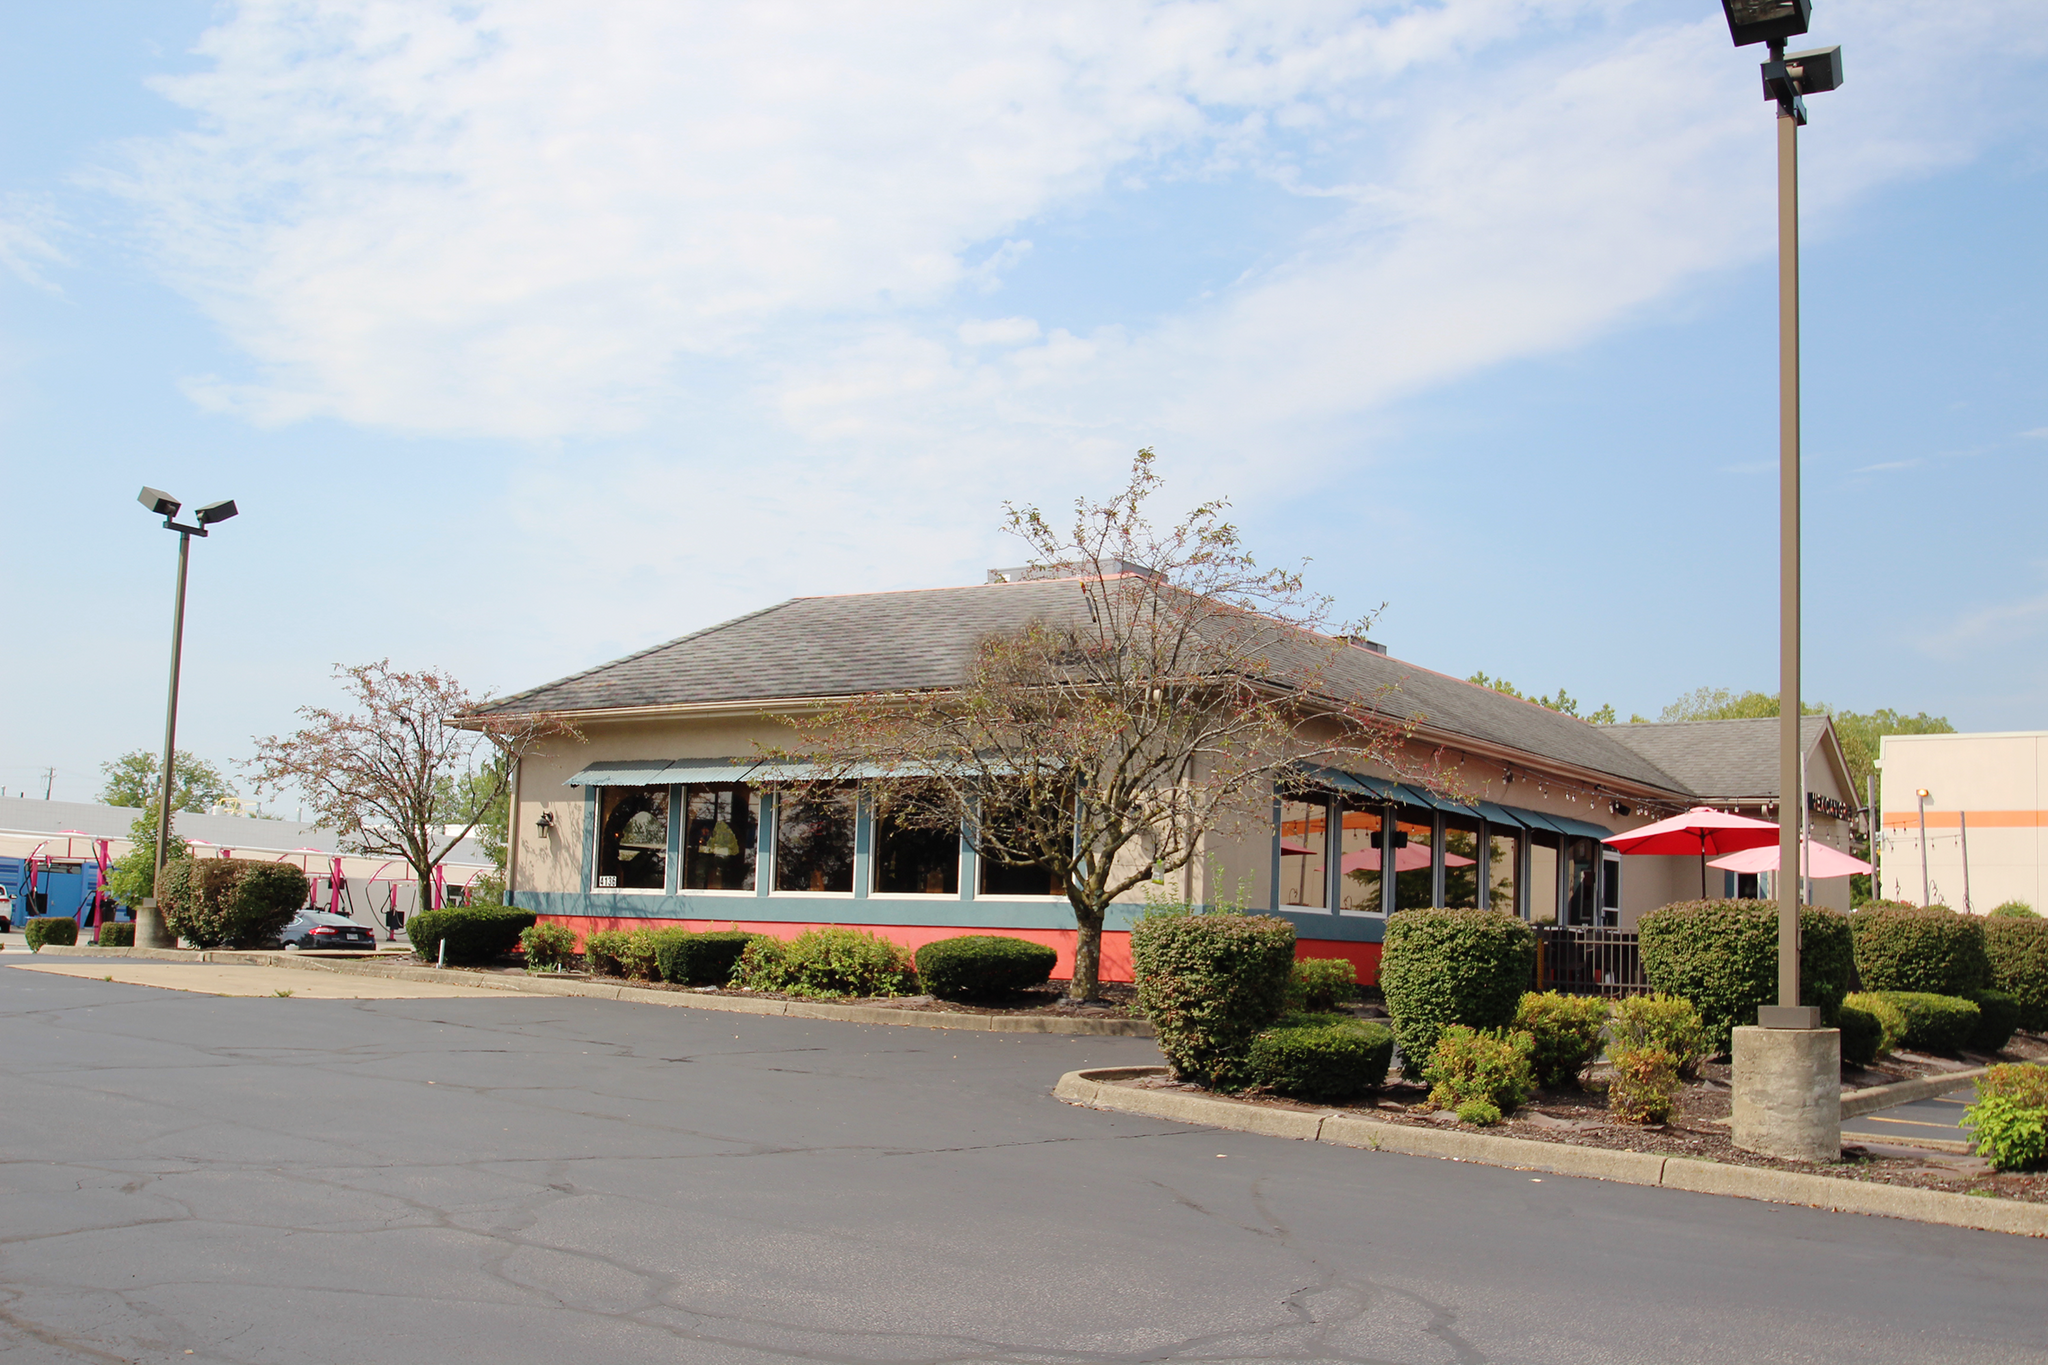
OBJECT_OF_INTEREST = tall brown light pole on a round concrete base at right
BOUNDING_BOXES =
[1720,0,1841,1160]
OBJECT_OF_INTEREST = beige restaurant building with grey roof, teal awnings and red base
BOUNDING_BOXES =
[489,577,1875,980]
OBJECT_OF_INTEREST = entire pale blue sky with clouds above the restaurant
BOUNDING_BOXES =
[0,0,2048,806]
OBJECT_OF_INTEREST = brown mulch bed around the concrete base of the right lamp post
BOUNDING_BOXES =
[1120,1033,2048,1203]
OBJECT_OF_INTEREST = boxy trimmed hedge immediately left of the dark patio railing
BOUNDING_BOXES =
[1380,909,1536,1080]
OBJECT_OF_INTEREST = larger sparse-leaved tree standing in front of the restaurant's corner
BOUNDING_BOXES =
[778,450,1433,1001]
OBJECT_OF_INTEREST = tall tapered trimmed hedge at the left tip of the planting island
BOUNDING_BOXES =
[1130,915,1294,1089]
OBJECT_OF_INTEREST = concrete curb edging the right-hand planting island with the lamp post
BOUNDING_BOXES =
[1053,1066,2048,1236]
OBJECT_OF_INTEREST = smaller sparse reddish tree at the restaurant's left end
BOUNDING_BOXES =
[248,659,575,916]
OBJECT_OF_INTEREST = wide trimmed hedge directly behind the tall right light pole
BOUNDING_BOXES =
[1636,900,1862,1052]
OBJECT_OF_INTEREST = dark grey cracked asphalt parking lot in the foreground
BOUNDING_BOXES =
[0,970,2048,1365]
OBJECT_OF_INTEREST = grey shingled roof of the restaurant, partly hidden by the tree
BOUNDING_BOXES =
[487,579,1694,796]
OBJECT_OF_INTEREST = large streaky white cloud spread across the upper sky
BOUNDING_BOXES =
[106,0,2048,663]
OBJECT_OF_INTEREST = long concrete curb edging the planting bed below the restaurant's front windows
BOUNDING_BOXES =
[63,943,1157,1038]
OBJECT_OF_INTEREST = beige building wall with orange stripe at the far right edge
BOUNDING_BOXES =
[1878,731,2048,915]
